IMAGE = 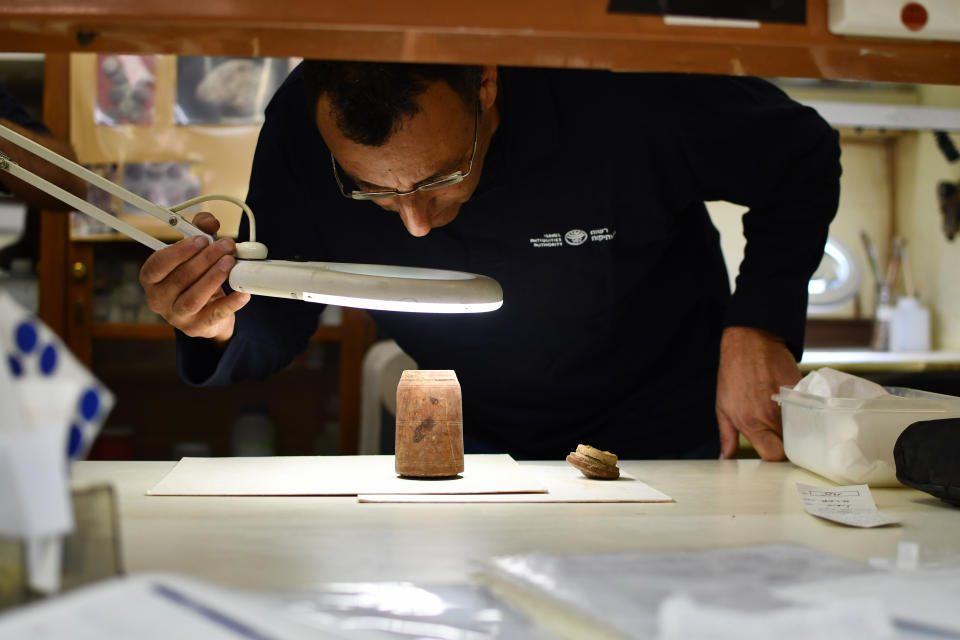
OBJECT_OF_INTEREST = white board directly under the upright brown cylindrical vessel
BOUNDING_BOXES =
[147,454,546,496]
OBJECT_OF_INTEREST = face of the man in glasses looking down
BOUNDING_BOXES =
[317,67,497,236]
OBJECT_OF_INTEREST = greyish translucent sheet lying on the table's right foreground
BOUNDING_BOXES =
[487,545,878,639]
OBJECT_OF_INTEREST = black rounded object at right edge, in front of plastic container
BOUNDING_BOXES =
[893,418,960,507]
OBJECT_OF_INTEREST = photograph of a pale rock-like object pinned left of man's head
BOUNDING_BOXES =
[173,56,295,125]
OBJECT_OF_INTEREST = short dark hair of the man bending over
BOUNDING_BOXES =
[303,60,482,147]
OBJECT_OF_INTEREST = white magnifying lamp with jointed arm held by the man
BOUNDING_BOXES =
[0,126,503,313]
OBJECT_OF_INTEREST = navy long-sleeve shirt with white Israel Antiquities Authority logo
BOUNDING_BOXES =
[178,68,840,458]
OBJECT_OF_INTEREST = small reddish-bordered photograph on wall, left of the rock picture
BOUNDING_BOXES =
[94,54,156,126]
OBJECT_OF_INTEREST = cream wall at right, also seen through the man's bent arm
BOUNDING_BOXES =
[708,86,960,350]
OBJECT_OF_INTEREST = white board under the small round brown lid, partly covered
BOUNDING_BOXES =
[357,462,673,503]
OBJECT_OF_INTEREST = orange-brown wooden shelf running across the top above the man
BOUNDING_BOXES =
[0,0,960,84]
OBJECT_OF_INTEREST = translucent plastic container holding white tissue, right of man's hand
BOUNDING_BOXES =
[774,387,960,487]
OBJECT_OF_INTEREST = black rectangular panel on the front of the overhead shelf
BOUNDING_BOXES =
[607,0,807,24]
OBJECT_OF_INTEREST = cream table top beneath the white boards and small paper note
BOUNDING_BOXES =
[73,460,960,591]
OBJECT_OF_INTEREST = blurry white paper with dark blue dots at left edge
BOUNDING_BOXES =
[0,291,113,592]
